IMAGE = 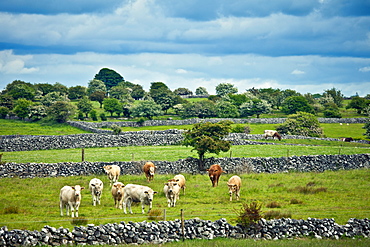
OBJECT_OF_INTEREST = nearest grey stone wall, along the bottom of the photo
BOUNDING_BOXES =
[0,218,370,246]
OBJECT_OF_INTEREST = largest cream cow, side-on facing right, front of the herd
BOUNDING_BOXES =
[123,184,157,214]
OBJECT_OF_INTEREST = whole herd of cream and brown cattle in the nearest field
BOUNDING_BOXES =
[59,162,241,217]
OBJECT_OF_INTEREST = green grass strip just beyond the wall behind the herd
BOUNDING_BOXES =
[1,142,370,163]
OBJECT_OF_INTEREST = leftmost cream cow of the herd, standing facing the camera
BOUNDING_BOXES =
[59,185,85,217]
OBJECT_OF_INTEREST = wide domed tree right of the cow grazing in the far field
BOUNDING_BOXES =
[276,112,323,137]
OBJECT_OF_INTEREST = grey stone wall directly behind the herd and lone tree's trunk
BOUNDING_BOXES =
[0,154,370,178]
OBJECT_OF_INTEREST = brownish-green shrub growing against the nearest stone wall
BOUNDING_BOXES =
[236,201,263,228]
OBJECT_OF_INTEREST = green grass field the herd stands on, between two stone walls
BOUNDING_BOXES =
[0,169,370,230]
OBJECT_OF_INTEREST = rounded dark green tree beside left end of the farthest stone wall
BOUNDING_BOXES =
[47,101,76,123]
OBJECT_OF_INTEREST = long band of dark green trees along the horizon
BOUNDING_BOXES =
[0,68,370,122]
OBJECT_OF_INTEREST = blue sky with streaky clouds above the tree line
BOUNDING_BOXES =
[0,0,370,96]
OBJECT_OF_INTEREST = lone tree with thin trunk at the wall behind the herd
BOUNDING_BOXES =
[182,121,232,170]
